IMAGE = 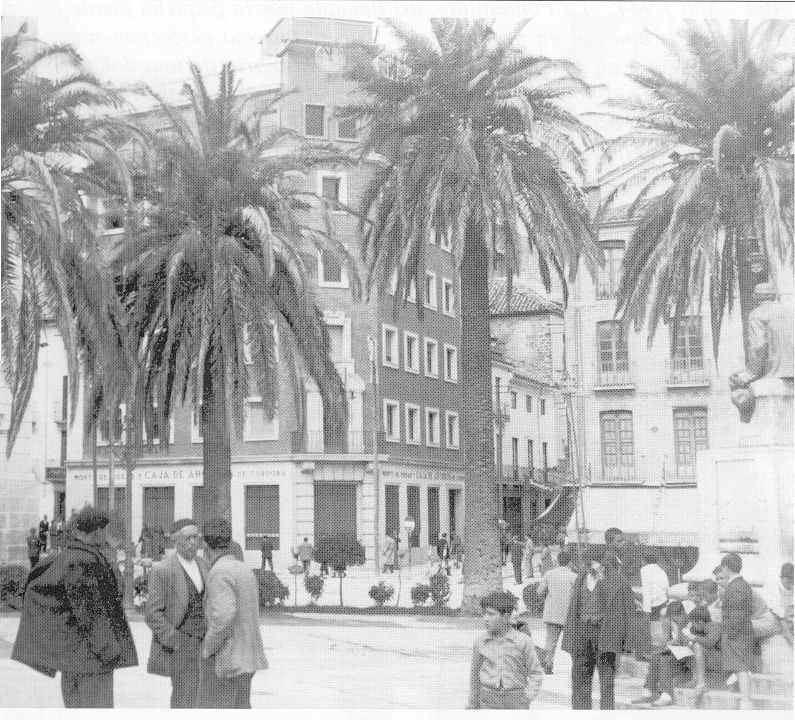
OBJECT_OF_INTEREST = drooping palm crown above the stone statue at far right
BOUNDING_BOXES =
[605,20,793,357]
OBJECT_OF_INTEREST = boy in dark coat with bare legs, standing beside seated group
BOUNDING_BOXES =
[719,553,754,710]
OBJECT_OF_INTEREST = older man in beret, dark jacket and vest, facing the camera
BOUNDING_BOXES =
[146,519,207,708]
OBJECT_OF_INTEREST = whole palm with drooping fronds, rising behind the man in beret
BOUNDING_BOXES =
[125,64,357,517]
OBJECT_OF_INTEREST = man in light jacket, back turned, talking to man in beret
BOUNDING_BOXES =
[197,518,268,708]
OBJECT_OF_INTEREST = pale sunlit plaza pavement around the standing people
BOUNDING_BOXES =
[0,565,640,710]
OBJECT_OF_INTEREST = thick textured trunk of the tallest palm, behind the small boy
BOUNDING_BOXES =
[461,219,502,614]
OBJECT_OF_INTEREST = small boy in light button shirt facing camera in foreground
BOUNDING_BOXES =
[467,591,544,710]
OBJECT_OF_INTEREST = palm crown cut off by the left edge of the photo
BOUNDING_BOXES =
[2,25,137,455]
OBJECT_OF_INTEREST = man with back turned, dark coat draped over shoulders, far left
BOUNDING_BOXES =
[11,506,138,707]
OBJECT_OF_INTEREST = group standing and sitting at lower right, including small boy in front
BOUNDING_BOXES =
[469,528,793,710]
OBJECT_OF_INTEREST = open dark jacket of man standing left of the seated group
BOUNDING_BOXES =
[561,571,635,655]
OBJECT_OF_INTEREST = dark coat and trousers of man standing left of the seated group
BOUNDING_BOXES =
[562,552,635,710]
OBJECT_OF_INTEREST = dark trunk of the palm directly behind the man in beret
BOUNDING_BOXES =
[202,341,232,521]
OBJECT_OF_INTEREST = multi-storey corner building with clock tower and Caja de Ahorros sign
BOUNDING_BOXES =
[67,18,464,564]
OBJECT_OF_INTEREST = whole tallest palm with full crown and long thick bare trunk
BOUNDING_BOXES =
[343,19,598,608]
